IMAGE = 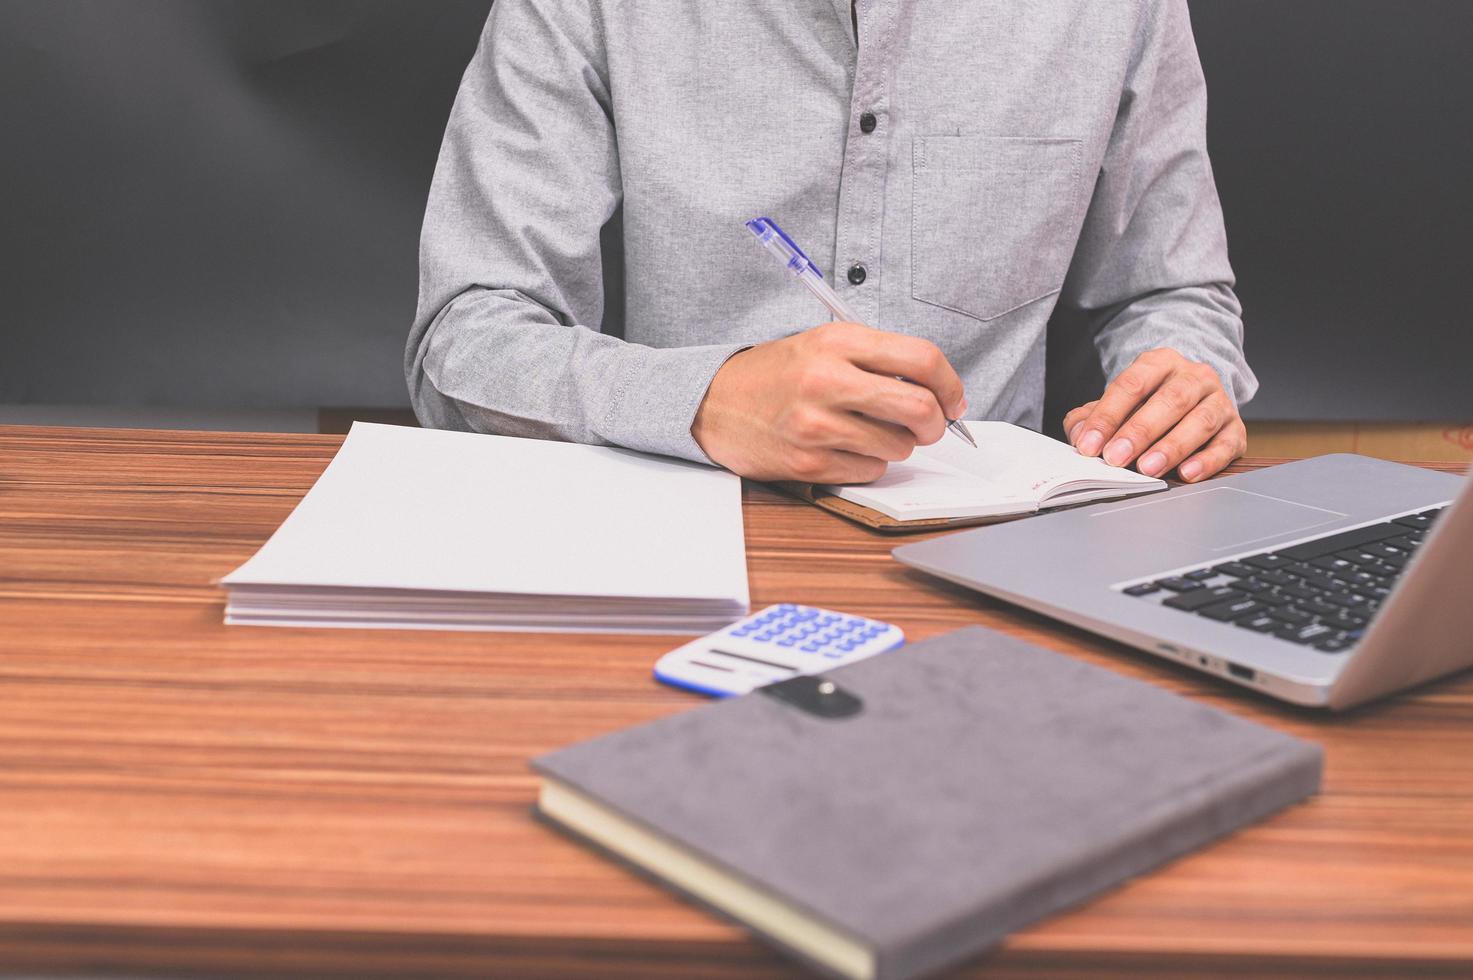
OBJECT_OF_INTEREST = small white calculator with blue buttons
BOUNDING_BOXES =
[654,603,906,697]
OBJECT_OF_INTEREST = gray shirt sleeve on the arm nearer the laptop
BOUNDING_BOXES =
[1059,0,1258,404]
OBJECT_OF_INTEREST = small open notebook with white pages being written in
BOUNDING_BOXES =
[785,421,1167,531]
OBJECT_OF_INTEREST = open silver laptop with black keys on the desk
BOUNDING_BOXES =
[894,454,1473,709]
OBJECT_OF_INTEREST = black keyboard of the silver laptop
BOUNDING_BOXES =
[1124,507,1442,653]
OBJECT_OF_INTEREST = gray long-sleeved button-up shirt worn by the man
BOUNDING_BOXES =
[405,0,1256,461]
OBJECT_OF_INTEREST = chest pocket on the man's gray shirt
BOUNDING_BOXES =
[910,136,1083,320]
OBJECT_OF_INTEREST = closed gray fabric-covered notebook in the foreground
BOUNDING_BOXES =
[532,628,1321,980]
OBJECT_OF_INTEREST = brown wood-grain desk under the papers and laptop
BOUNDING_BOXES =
[0,427,1473,979]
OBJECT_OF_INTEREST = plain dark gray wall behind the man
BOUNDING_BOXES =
[0,0,1473,420]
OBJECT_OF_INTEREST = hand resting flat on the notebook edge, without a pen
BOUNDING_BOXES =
[1064,348,1248,483]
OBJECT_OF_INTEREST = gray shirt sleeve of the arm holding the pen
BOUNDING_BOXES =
[405,0,739,463]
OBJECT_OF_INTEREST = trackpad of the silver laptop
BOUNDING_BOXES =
[1094,486,1348,553]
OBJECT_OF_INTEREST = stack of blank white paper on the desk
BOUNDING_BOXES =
[221,421,750,632]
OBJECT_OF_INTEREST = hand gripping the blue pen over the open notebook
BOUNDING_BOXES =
[691,323,966,483]
